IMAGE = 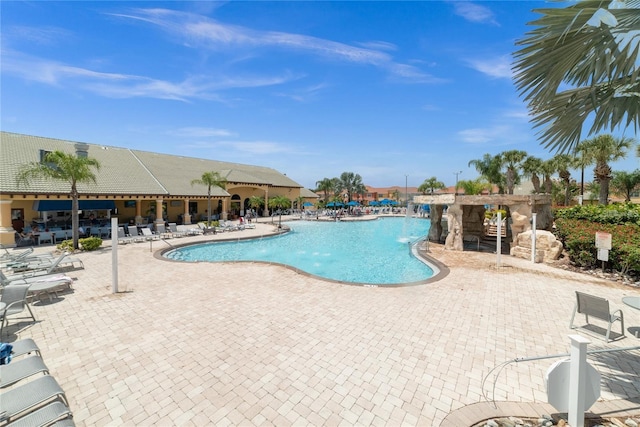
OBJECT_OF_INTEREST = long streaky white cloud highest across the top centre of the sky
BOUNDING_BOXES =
[114,9,437,82]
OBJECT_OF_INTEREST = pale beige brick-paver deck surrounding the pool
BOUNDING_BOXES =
[8,219,640,426]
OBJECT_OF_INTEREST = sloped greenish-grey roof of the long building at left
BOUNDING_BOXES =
[0,132,302,197]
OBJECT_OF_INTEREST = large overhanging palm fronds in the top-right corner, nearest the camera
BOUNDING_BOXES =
[514,0,640,152]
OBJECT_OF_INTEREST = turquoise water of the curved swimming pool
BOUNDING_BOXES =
[165,218,434,285]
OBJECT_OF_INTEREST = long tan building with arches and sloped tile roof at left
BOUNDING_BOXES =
[0,132,307,244]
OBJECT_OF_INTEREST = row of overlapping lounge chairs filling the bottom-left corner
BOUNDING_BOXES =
[0,338,75,427]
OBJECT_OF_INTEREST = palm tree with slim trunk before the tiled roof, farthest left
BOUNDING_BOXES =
[17,151,100,249]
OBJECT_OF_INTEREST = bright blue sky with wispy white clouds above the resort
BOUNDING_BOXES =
[0,1,639,188]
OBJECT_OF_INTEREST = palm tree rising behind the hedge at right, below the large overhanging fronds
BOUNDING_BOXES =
[581,134,633,205]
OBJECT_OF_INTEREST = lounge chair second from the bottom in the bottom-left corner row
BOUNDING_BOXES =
[0,375,69,425]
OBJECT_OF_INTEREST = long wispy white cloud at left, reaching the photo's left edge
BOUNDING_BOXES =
[2,49,298,101]
